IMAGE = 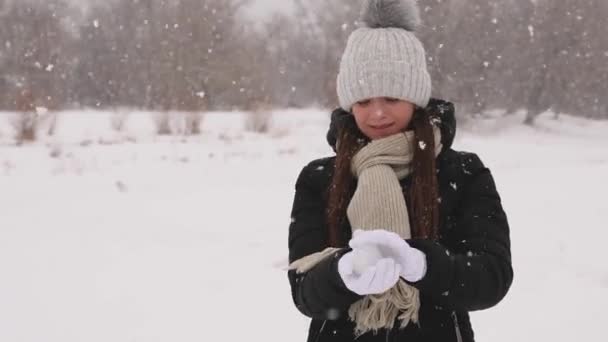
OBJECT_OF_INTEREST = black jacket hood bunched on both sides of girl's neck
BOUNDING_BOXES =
[327,98,456,152]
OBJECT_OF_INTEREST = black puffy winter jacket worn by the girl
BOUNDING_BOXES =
[288,100,513,342]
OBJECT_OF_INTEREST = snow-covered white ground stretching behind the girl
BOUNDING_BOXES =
[0,110,608,342]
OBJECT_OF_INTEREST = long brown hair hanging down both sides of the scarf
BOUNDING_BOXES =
[327,108,439,247]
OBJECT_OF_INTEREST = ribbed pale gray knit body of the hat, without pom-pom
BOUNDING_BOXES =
[337,27,431,111]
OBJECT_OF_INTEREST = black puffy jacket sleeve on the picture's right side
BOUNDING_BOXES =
[409,154,513,311]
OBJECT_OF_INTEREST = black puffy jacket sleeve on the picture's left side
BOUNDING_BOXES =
[288,164,361,320]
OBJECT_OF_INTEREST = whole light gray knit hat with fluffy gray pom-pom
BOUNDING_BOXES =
[337,0,431,111]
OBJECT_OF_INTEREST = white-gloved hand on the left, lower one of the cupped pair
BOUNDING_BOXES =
[338,250,401,295]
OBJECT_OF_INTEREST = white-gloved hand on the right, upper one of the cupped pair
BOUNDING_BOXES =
[349,229,427,282]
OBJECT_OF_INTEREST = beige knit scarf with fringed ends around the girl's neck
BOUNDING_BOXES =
[289,128,442,336]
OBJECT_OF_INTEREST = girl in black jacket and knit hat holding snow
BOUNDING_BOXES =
[288,0,513,342]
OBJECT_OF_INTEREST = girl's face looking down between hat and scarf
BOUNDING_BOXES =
[352,97,414,140]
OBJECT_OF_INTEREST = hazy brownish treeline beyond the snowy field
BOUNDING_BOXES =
[0,0,608,122]
